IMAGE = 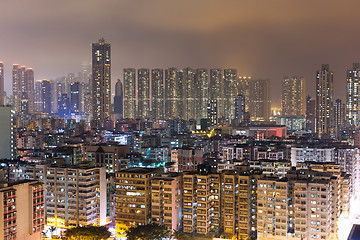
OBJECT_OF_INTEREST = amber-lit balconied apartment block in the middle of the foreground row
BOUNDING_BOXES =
[183,169,259,238]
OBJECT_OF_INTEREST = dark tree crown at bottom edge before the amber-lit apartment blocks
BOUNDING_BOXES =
[126,223,171,240]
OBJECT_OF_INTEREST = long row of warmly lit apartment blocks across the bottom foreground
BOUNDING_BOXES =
[116,166,351,239]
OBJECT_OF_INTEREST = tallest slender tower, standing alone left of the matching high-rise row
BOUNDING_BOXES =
[92,38,111,122]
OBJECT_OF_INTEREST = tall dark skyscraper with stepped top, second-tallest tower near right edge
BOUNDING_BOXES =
[316,64,334,137]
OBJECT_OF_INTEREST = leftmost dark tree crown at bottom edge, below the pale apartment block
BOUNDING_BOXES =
[65,226,111,240]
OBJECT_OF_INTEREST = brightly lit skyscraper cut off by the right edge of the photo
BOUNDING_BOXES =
[346,63,360,128]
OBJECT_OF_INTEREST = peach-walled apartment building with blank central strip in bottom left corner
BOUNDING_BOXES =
[0,180,45,240]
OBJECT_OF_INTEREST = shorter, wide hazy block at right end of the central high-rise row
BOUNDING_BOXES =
[247,79,270,121]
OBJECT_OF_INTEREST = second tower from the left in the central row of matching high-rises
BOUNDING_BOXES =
[137,68,150,118]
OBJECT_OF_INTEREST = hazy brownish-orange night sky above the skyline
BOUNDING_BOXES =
[0,0,360,105]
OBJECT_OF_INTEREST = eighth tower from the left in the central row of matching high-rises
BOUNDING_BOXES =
[221,69,238,119]
